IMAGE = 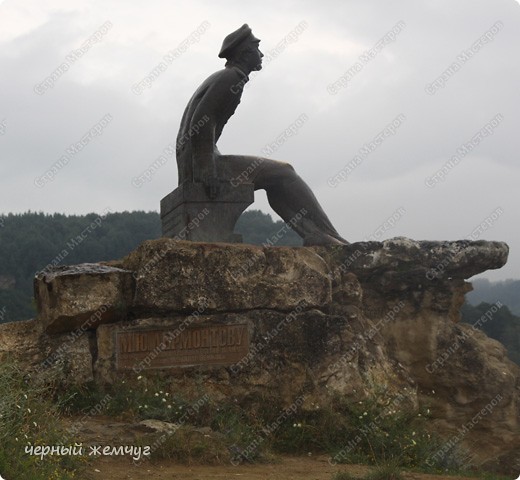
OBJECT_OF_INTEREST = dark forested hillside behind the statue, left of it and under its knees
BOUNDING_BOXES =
[0,210,301,323]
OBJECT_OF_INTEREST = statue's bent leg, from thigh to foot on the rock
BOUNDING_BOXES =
[219,155,348,245]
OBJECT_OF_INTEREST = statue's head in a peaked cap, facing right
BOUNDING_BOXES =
[218,23,264,71]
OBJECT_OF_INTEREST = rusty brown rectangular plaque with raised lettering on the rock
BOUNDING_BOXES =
[116,325,249,370]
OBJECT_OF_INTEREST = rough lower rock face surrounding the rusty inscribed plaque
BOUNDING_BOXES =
[95,309,410,405]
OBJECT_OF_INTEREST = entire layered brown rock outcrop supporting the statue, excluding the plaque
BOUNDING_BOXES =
[0,238,520,471]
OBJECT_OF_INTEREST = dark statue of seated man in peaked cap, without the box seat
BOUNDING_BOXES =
[176,24,348,245]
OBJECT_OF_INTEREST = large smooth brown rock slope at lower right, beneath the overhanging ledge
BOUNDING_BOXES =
[374,304,520,471]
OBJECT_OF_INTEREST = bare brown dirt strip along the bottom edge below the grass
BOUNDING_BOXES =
[84,456,486,480]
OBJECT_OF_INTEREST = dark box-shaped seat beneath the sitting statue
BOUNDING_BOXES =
[161,182,254,243]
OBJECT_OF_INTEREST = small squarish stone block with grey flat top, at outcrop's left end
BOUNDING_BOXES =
[34,263,133,333]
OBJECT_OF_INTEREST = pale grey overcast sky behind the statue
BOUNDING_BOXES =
[0,0,520,280]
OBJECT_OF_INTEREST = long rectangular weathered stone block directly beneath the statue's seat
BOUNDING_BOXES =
[122,239,332,313]
